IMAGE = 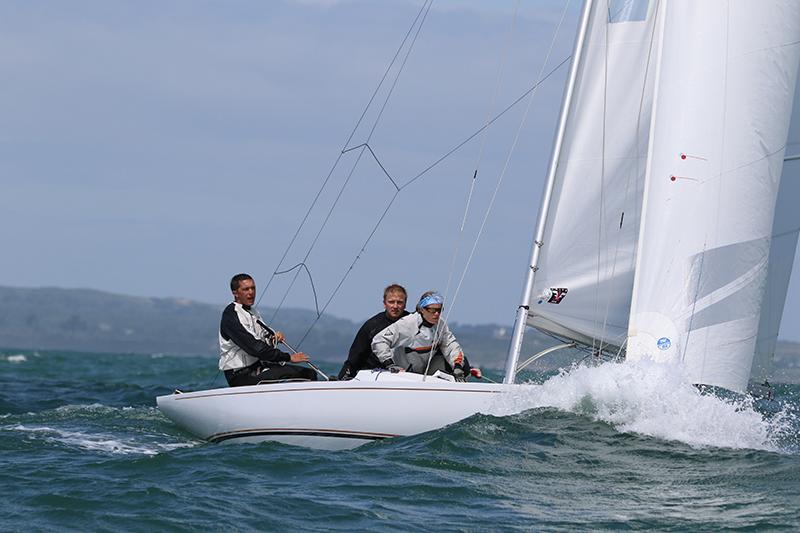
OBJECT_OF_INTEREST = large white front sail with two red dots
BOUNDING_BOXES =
[627,0,800,391]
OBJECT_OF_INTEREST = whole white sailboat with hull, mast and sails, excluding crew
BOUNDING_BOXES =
[157,0,800,449]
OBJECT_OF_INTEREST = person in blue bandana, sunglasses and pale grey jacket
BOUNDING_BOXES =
[372,291,466,381]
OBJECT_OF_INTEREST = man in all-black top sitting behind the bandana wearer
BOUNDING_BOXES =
[339,283,408,380]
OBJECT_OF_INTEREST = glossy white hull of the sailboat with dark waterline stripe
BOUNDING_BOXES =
[157,371,513,450]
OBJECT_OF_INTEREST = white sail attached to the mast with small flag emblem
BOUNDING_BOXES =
[527,0,658,348]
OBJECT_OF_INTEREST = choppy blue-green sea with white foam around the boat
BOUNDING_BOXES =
[0,350,800,532]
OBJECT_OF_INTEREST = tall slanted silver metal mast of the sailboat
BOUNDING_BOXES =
[503,0,593,383]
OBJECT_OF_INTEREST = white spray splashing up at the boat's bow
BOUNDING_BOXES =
[490,361,798,452]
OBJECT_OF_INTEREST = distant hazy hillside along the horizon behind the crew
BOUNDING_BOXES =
[0,287,800,382]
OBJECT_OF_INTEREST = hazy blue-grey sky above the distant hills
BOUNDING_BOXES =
[0,0,800,340]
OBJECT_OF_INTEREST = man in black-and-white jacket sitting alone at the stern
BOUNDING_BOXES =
[219,274,317,387]
